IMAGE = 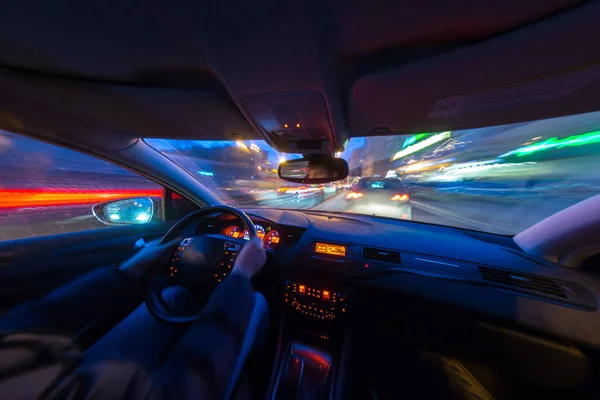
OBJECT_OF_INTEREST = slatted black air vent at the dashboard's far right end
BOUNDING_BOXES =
[479,267,567,299]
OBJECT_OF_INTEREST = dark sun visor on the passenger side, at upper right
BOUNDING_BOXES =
[349,2,600,134]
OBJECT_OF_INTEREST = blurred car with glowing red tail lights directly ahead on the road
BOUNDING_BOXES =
[344,178,412,219]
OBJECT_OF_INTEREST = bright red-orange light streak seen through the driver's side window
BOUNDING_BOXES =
[0,188,162,209]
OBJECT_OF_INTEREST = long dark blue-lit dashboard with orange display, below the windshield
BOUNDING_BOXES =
[188,209,600,348]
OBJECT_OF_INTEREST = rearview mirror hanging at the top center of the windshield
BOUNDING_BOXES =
[278,156,348,184]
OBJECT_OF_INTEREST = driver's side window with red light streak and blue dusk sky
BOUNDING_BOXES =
[0,130,162,241]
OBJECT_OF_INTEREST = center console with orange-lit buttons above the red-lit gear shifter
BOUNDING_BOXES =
[271,280,349,400]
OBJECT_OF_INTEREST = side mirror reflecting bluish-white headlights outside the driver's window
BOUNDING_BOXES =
[92,197,159,225]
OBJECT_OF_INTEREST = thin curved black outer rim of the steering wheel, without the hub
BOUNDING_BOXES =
[145,205,256,324]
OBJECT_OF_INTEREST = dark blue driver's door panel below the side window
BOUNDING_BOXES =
[0,222,172,313]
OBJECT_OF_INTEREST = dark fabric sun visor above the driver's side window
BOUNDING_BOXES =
[0,69,258,146]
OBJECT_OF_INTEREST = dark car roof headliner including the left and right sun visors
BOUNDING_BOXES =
[0,0,600,153]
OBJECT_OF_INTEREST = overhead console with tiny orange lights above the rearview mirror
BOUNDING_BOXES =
[242,92,334,154]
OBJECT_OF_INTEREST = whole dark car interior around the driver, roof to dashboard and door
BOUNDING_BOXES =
[0,0,600,400]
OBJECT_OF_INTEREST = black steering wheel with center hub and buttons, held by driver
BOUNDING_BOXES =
[146,205,256,324]
